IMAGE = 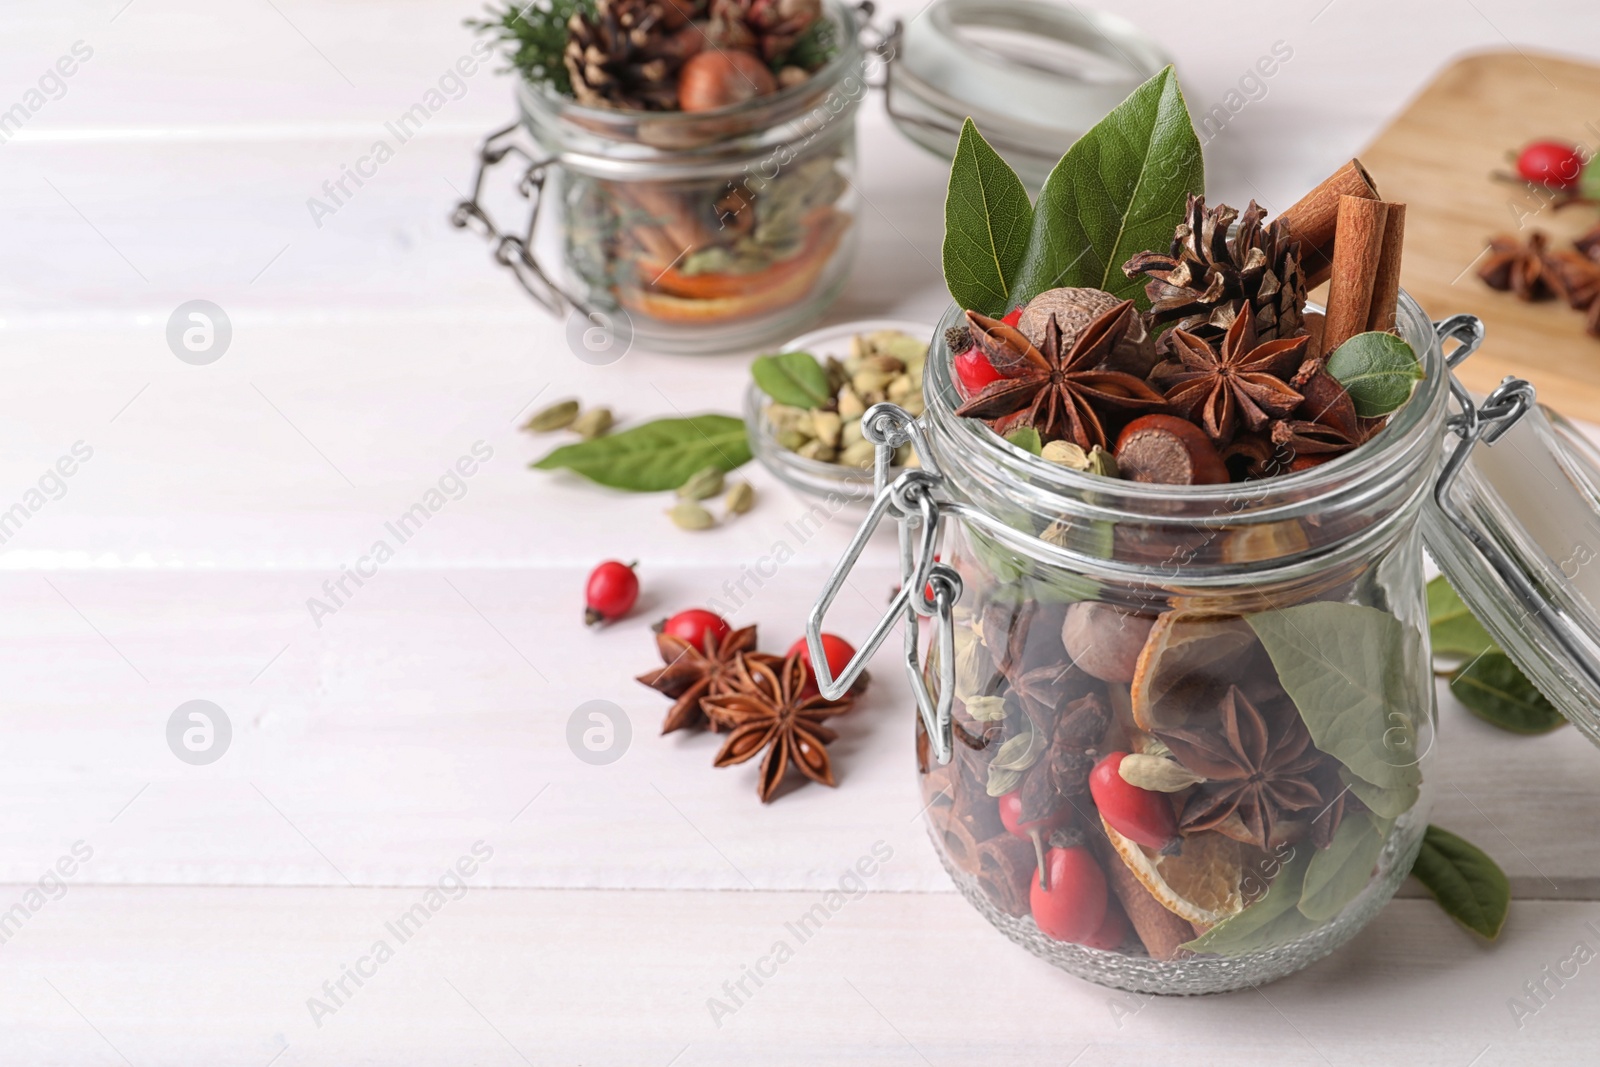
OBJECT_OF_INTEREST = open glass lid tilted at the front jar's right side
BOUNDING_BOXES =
[1422,323,1600,744]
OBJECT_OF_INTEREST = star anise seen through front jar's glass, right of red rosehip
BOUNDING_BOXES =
[1158,686,1328,849]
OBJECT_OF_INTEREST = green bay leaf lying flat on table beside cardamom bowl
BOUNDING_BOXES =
[531,414,750,493]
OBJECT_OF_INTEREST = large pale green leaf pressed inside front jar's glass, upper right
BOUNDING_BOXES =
[1248,601,1427,789]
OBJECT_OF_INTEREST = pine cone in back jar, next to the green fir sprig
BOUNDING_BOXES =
[563,0,701,110]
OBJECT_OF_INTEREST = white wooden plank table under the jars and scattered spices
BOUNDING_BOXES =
[0,0,1600,1067]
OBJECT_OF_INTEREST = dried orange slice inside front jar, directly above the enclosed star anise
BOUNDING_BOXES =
[1131,611,1259,731]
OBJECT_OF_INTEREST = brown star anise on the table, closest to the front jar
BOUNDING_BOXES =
[701,653,854,803]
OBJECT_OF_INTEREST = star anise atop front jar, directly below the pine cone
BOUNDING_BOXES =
[1150,308,1310,445]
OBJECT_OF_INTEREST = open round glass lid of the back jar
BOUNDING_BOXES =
[888,0,1171,190]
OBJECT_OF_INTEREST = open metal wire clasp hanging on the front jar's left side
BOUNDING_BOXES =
[805,403,962,763]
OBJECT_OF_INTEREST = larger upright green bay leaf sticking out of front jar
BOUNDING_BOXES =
[1011,67,1205,307]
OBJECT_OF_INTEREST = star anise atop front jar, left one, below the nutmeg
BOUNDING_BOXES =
[955,301,1166,450]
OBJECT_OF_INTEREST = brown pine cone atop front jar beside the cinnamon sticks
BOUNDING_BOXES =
[1122,197,1306,347]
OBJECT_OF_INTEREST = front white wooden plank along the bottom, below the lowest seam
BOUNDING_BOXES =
[0,895,1600,1067]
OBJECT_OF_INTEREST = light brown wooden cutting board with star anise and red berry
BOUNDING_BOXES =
[1362,51,1600,422]
